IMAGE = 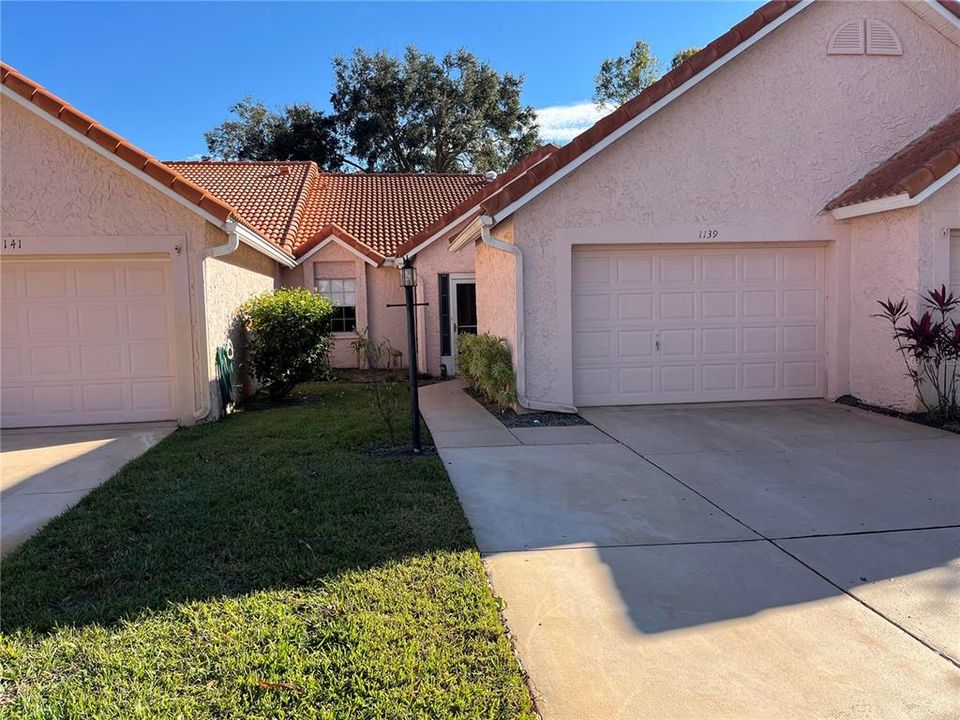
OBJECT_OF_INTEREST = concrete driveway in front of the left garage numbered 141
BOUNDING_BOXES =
[0,423,177,555]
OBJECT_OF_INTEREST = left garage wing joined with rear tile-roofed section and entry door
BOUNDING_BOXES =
[0,66,499,427]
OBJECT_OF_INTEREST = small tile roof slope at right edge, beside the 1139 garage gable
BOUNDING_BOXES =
[826,109,960,210]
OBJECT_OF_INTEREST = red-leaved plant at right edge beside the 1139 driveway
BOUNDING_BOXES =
[875,285,960,422]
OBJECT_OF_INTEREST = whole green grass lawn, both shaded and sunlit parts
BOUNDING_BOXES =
[0,384,533,720]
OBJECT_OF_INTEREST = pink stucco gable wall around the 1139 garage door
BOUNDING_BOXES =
[502,2,960,403]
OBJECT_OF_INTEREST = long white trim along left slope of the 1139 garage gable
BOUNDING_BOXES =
[493,0,814,224]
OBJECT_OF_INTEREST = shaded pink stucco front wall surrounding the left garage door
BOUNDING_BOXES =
[0,97,251,422]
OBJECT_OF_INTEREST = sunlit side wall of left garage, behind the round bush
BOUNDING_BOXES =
[204,244,278,400]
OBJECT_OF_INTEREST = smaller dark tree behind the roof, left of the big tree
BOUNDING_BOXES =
[204,97,342,170]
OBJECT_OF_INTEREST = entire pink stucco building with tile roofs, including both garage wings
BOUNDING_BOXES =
[0,0,960,426]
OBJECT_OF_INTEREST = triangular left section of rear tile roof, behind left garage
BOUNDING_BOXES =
[164,161,317,252]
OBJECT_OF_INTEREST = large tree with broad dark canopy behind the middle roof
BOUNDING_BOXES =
[331,46,540,172]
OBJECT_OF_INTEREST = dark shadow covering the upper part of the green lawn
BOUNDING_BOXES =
[0,384,464,632]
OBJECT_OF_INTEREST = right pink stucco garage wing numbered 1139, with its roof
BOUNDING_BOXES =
[416,0,960,411]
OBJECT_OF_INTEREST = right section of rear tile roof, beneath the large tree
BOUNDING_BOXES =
[293,173,484,257]
